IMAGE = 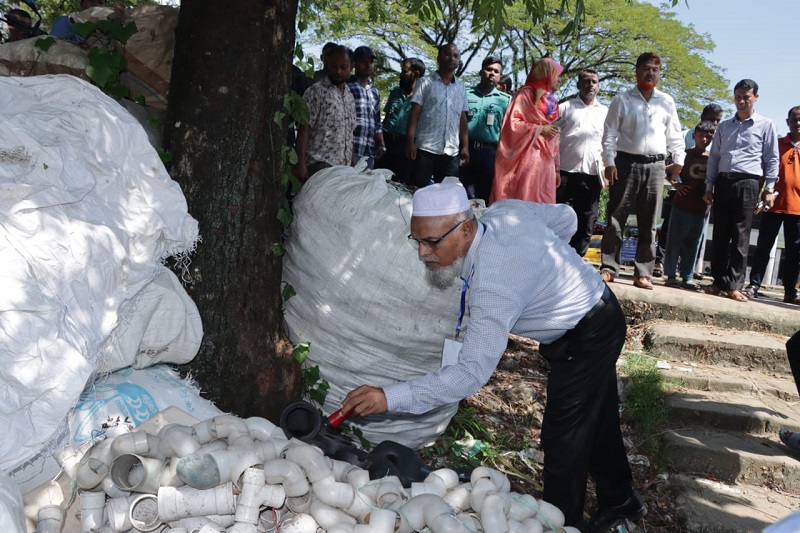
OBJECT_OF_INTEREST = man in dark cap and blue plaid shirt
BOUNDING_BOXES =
[347,46,386,168]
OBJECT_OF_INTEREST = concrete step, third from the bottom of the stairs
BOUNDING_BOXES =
[664,390,800,434]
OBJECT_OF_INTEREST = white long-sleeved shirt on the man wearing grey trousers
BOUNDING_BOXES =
[603,87,686,167]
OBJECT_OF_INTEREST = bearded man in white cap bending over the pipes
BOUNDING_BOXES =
[342,183,647,532]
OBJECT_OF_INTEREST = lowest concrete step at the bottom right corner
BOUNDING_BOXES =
[669,475,800,533]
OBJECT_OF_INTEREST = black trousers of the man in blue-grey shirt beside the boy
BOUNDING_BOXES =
[711,176,759,291]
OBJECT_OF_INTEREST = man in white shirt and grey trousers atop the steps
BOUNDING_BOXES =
[600,52,686,290]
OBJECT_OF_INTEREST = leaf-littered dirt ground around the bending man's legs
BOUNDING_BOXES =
[423,337,682,533]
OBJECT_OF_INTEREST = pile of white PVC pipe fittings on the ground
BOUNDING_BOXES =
[28,415,578,533]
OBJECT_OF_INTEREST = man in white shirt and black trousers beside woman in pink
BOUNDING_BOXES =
[556,68,608,257]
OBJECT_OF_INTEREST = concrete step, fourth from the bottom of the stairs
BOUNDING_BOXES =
[659,360,800,402]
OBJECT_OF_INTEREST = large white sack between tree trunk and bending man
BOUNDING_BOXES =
[283,167,466,448]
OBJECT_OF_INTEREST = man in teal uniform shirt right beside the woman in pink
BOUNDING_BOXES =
[461,56,511,203]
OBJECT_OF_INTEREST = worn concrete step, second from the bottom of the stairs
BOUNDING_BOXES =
[661,428,800,490]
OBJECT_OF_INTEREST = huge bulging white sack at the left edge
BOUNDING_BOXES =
[0,75,198,471]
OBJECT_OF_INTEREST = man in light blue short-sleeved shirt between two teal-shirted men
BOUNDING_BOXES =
[406,44,469,187]
